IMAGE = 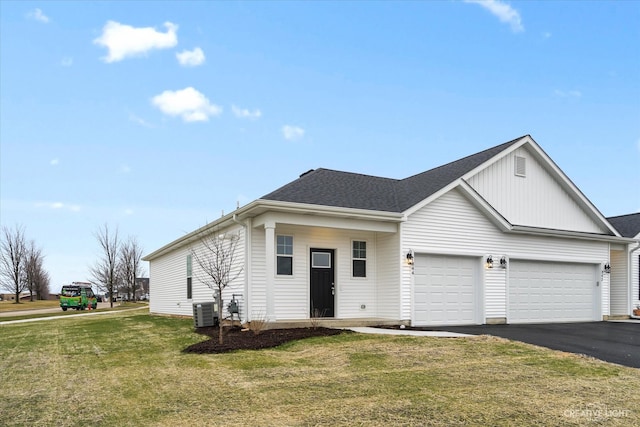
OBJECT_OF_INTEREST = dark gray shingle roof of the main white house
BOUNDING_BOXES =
[261,137,524,212]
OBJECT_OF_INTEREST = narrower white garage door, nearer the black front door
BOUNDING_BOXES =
[412,255,479,326]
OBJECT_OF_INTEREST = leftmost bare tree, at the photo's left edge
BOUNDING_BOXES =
[0,225,27,304]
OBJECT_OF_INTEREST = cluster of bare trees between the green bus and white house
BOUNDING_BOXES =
[90,224,144,307]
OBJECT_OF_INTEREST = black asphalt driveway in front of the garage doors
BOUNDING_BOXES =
[430,322,640,368]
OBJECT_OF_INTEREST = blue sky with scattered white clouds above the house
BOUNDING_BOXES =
[0,0,640,291]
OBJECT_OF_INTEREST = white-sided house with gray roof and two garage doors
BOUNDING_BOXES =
[144,135,637,326]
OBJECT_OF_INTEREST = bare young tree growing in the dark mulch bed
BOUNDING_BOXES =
[190,229,243,344]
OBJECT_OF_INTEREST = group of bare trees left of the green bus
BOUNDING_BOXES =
[0,225,51,303]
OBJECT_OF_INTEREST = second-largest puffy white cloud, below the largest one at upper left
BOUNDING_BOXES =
[151,87,222,122]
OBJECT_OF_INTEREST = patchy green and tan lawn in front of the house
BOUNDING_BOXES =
[0,311,640,427]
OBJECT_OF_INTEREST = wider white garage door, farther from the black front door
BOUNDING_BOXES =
[507,260,599,323]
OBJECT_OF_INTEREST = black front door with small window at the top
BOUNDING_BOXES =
[310,249,335,317]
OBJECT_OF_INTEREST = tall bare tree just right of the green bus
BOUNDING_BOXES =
[89,224,120,308]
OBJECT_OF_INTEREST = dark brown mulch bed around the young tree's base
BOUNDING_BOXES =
[183,326,345,354]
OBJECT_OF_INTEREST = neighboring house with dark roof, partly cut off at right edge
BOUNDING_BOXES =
[607,212,640,318]
